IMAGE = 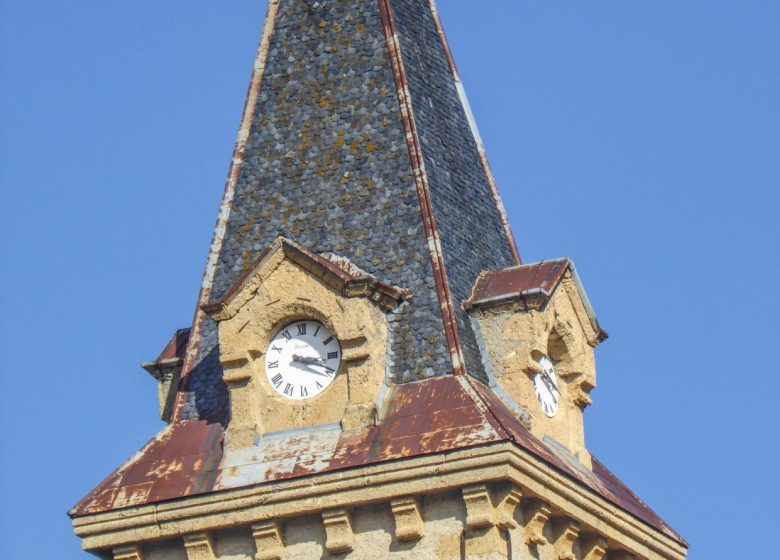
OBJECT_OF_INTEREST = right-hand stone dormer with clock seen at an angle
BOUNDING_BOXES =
[464,259,607,467]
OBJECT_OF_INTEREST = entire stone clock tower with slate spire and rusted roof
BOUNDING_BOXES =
[69,0,687,560]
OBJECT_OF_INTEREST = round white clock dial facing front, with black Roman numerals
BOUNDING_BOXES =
[265,320,341,400]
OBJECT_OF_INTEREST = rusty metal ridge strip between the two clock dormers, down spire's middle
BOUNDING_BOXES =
[378,0,466,375]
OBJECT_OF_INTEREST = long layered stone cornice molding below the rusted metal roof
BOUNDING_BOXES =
[73,443,686,560]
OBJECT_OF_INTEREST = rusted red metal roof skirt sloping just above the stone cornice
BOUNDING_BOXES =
[69,376,684,543]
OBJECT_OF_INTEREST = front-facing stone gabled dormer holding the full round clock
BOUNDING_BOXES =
[203,237,411,449]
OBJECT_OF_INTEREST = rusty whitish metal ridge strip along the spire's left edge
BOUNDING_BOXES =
[171,0,280,422]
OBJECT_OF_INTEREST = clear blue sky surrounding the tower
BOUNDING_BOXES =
[0,0,780,559]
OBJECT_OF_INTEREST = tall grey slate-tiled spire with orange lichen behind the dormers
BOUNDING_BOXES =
[177,0,519,418]
